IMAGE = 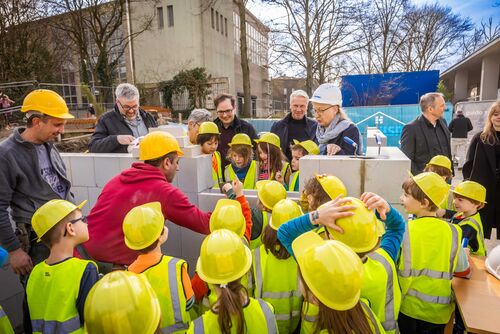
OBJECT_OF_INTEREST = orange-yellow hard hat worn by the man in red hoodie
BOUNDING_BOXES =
[139,131,184,161]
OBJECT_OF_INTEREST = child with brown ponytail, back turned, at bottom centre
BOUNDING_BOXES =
[188,229,277,333]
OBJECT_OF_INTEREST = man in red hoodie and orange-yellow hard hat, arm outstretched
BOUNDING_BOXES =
[77,132,210,271]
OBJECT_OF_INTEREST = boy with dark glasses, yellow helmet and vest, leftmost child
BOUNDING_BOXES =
[26,199,98,333]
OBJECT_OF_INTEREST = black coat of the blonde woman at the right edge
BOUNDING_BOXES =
[462,132,500,239]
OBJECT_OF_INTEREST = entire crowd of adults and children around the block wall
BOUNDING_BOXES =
[0,84,500,334]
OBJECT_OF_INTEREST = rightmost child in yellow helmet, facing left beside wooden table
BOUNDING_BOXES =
[452,181,486,256]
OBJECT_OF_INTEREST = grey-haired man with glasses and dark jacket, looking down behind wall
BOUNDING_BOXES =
[89,83,158,153]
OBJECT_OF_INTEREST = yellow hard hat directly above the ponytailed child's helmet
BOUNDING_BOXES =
[210,198,246,237]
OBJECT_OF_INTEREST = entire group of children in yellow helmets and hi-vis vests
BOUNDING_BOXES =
[0,147,485,334]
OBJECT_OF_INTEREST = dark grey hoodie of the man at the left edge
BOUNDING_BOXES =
[0,128,72,252]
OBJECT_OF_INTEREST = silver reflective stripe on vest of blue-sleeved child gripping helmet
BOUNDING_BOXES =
[361,251,401,331]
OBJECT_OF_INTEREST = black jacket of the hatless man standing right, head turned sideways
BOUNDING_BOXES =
[401,115,453,175]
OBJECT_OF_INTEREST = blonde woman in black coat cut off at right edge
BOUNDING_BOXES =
[462,100,500,239]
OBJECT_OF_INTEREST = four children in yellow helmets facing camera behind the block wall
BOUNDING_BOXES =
[197,122,319,191]
